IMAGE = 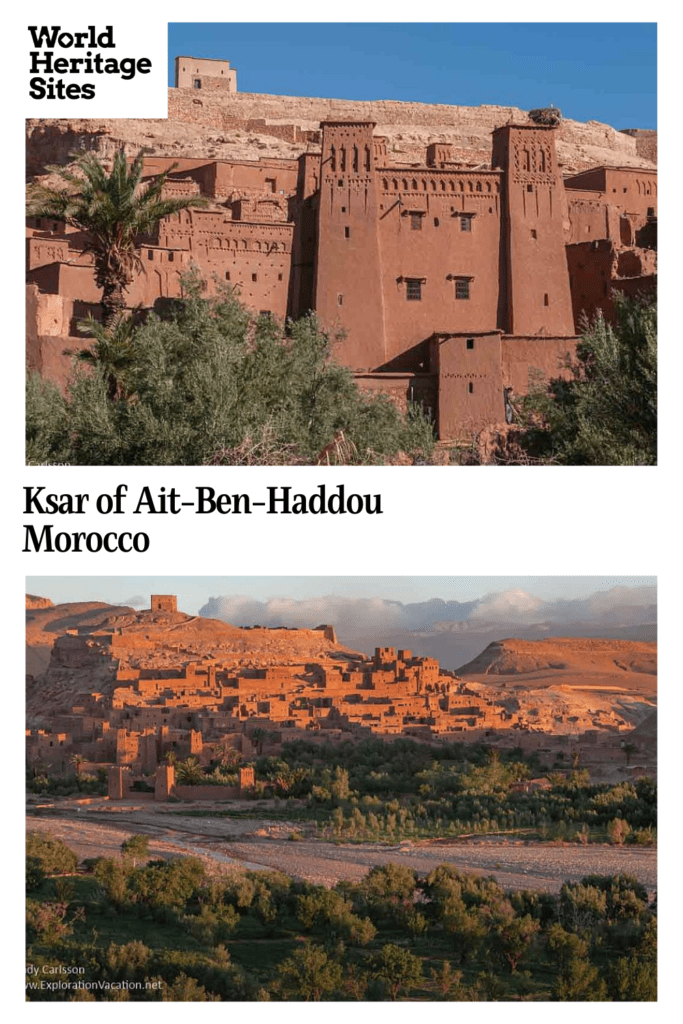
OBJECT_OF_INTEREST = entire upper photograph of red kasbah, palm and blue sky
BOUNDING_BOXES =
[26,24,657,467]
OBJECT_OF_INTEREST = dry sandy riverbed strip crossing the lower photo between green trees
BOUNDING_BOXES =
[27,805,656,895]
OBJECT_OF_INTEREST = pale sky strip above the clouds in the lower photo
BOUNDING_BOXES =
[27,575,655,614]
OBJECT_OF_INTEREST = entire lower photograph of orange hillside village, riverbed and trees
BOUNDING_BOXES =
[26,575,657,1002]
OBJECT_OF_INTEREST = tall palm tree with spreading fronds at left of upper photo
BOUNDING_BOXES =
[27,148,206,326]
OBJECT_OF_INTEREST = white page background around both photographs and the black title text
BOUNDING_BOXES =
[2,0,683,1020]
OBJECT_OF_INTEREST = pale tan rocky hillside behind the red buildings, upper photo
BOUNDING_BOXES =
[27,89,656,176]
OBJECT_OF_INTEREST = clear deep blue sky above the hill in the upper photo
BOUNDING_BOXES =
[169,23,656,128]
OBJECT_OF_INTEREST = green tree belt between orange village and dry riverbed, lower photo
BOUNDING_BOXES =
[225,739,656,845]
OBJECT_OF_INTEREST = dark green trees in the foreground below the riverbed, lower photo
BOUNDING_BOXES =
[27,835,656,1001]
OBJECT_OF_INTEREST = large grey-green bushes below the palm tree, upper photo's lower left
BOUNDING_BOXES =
[27,273,433,466]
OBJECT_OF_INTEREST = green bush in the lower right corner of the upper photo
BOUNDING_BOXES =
[522,293,657,466]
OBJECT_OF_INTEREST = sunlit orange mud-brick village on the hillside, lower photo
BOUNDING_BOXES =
[27,595,650,800]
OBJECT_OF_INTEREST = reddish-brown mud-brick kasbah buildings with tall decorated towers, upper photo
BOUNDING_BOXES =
[28,57,656,439]
